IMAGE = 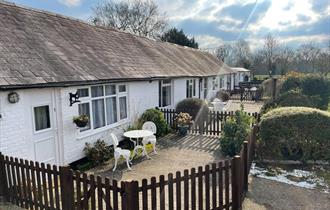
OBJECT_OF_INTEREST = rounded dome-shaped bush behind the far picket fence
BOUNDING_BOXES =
[175,98,209,119]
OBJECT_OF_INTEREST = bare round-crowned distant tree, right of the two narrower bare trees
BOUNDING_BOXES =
[297,42,321,72]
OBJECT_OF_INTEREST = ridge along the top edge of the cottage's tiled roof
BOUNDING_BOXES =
[0,0,206,54]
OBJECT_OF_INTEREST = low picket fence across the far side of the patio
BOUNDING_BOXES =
[159,108,260,136]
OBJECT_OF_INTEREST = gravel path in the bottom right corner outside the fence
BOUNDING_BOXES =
[243,177,330,210]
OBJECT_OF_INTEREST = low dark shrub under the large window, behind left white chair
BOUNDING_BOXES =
[84,139,113,166]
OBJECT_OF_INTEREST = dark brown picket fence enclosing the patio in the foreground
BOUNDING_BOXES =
[0,126,258,210]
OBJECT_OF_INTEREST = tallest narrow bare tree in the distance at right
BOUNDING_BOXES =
[263,34,279,76]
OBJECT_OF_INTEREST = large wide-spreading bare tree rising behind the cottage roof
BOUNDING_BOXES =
[91,0,167,38]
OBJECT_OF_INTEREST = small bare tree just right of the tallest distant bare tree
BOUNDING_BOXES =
[276,47,295,75]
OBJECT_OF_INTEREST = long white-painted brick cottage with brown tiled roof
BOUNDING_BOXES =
[0,3,230,165]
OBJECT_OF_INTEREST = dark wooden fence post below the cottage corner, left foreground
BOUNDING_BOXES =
[60,166,75,210]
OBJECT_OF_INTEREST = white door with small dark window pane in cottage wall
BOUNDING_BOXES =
[30,89,58,164]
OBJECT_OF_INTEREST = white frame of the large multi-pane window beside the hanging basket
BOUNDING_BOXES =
[77,83,129,134]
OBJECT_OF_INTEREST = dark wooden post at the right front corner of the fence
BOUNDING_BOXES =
[231,155,241,210]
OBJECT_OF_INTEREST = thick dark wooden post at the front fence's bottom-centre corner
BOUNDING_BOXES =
[123,181,139,210]
